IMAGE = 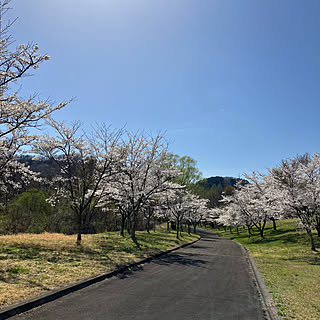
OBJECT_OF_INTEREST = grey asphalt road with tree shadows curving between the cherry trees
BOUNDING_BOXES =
[11,231,265,320]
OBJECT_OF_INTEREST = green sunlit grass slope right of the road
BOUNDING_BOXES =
[212,219,320,320]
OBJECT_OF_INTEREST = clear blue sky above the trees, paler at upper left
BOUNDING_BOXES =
[10,0,320,177]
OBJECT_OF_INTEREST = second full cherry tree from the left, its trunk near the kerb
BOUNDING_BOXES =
[107,133,177,241]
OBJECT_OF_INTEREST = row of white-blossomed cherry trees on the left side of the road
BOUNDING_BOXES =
[33,119,208,243]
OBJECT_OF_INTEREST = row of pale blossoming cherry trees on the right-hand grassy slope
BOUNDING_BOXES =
[215,153,320,250]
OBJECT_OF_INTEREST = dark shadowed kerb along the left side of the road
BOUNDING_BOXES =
[0,237,201,320]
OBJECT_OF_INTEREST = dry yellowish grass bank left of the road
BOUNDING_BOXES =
[0,229,198,308]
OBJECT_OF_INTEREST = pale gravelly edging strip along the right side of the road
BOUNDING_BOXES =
[236,242,282,320]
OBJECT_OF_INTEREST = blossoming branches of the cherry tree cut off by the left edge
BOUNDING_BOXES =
[0,0,68,208]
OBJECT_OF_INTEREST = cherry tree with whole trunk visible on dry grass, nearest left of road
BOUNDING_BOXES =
[33,120,125,244]
